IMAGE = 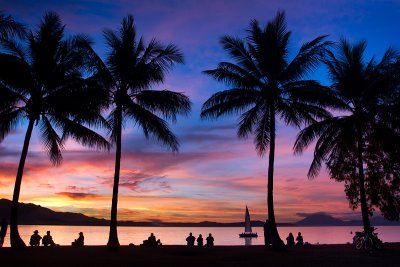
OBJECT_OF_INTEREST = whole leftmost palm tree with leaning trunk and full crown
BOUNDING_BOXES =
[0,13,109,249]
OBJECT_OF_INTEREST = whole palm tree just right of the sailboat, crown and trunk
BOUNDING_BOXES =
[201,12,329,249]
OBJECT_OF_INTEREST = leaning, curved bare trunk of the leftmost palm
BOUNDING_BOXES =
[10,119,35,250]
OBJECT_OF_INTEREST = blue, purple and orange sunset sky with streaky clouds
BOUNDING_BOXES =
[0,0,400,222]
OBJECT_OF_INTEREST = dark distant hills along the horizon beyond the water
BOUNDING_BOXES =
[0,199,400,227]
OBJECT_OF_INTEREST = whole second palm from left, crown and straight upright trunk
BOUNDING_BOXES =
[97,15,191,249]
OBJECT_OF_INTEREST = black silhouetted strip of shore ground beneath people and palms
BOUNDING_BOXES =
[0,243,400,267]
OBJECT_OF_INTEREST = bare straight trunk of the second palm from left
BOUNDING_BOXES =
[107,107,122,250]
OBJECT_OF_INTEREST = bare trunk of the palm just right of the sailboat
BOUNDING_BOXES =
[267,104,286,250]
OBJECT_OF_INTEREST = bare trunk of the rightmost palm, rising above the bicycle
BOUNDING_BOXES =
[357,128,371,232]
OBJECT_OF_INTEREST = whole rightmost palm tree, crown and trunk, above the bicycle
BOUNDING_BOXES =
[294,39,399,234]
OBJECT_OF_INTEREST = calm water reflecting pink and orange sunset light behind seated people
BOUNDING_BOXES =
[4,225,400,247]
